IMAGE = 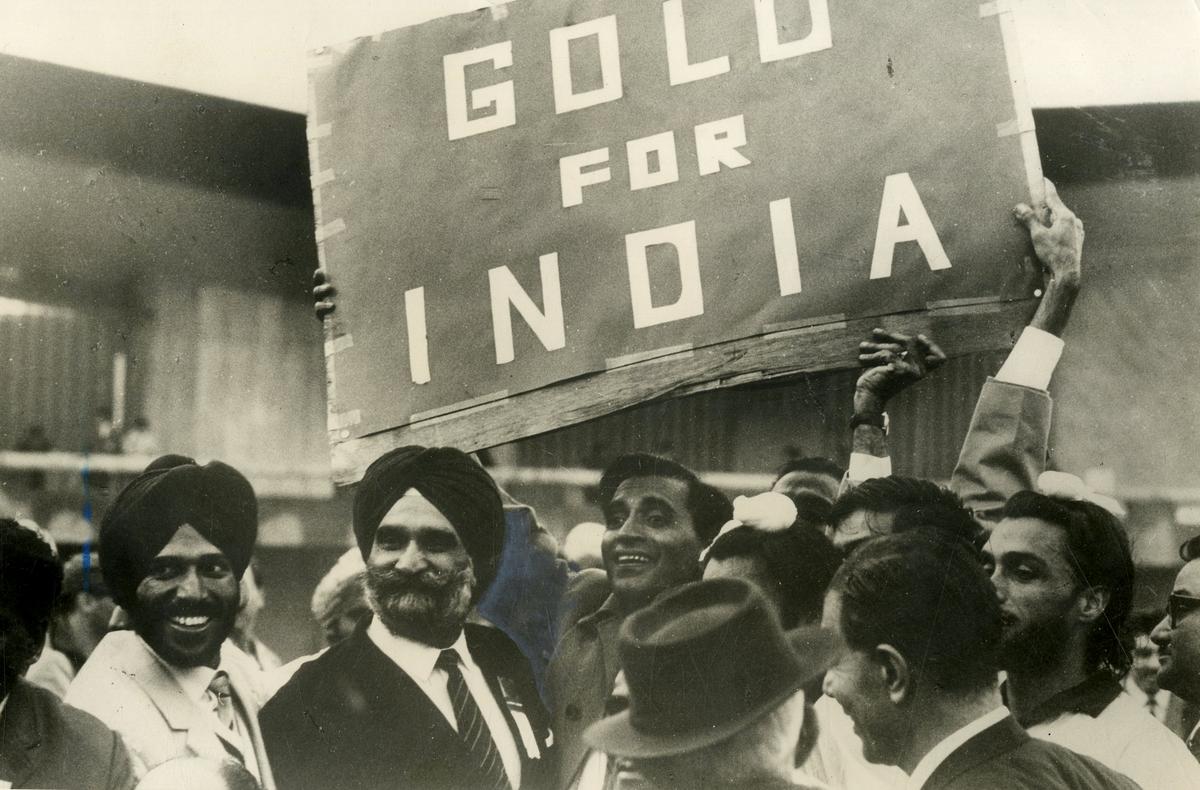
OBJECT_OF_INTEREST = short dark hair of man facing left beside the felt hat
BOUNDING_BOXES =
[832,531,1001,693]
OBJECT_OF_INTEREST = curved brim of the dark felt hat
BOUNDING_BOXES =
[583,626,846,759]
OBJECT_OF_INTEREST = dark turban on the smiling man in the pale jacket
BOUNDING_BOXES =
[100,455,258,609]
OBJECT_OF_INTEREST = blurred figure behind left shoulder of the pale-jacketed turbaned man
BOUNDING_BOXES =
[26,547,116,698]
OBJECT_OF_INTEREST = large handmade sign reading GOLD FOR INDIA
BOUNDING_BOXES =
[308,0,1040,481]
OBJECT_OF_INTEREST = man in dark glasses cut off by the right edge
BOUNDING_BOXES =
[1150,537,1200,759]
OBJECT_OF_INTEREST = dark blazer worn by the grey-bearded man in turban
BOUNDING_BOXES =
[259,624,551,790]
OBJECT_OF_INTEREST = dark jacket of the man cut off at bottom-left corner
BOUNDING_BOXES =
[0,680,133,790]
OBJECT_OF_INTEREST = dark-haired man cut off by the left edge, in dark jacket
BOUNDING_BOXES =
[0,519,133,790]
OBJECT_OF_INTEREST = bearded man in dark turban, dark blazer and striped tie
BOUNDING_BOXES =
[262,447,548,790]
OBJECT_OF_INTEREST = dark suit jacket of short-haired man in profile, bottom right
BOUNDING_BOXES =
[922,716,1138,790]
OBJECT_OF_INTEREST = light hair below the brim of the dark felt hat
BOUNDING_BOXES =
[636,692,810,790]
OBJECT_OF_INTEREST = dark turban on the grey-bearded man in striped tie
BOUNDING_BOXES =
[354,447,504,592]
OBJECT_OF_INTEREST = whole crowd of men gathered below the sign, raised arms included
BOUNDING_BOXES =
[0,184,1200,790]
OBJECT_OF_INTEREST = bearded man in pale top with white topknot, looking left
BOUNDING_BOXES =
[984,489,1200,790]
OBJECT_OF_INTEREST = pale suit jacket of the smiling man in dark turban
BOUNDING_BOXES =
[66,630,275,790]
